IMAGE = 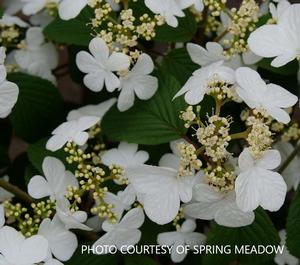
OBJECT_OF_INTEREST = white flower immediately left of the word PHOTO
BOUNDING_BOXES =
[38,216,78,261]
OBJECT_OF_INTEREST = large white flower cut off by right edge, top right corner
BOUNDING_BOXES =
[248,4,300,67]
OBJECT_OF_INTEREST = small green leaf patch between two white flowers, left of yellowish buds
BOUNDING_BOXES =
[27,138,66,174]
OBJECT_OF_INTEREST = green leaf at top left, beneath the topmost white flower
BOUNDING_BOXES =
[44,7,92,46]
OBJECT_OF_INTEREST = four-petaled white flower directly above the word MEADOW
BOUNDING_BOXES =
[235,148,287,212]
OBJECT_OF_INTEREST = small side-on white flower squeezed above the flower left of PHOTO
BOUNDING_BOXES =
[56,198,92,231]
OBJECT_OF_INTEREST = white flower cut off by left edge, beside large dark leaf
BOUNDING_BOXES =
[0,47,19,118]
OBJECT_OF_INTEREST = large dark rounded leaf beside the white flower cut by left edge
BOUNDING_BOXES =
[8,73,64,142]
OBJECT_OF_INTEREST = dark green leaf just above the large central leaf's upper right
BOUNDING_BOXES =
[162,48,200,85]
